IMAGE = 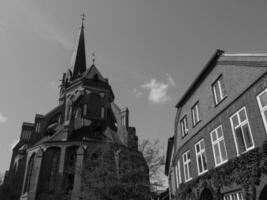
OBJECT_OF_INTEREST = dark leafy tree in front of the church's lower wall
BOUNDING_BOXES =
[81,146,150,200]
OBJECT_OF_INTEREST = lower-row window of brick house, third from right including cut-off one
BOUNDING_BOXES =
[210,126,228,167]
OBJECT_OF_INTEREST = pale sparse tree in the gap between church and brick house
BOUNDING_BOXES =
[139,139,166,191]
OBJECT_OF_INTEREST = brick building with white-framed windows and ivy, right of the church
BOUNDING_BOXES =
[165,50,267,200]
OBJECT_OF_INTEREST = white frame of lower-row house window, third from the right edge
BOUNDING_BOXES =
[210,125,228,167]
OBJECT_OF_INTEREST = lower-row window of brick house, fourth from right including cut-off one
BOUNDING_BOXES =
[195,139,208,175]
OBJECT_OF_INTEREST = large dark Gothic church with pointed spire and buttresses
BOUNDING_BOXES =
[3,20,149,200]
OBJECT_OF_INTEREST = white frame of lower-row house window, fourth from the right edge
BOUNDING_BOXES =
[195,139,208,175]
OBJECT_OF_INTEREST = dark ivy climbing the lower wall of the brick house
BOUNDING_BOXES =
[177,148,267,199]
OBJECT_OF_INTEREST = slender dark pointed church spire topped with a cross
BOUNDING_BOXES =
[72,14,86,79]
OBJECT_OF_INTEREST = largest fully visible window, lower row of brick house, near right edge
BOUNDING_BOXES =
[230,107,254,155]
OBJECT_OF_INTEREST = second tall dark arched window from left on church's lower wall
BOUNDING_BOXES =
[49,151,59,190]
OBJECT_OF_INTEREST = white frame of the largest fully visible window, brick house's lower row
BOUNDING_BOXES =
[230,106,255,156]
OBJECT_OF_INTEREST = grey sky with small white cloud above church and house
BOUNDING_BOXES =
[0,0,267,172]
